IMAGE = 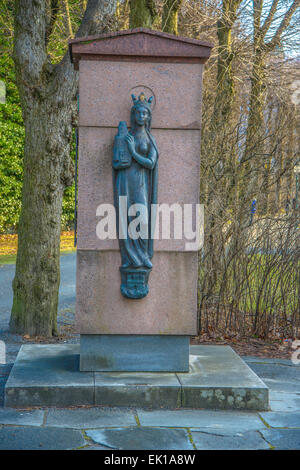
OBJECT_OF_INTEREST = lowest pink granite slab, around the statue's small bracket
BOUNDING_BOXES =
[76,250,198,335]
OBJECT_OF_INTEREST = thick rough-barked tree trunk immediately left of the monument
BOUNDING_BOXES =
[10,0,116,336]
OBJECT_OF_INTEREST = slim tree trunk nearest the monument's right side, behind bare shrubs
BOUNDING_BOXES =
[202,0,242,285]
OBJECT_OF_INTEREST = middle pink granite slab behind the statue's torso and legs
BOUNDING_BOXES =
[78,127,200,251]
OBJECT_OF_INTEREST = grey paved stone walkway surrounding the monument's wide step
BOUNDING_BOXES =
[0,255,300,451]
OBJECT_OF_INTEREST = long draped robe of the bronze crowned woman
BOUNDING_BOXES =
[113,131,158,267]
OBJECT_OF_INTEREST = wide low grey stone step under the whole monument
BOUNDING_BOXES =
[5,344,269,411]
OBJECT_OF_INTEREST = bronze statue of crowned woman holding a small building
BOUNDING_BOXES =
[112,93,158,299]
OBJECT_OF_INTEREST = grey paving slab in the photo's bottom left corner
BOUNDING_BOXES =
[0,426,85,450]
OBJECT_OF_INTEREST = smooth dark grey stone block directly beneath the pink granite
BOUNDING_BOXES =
[80,335,190,372]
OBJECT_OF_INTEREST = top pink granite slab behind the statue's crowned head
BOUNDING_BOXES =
[79,60,203,129]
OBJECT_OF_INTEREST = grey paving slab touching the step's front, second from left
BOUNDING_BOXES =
[46,407,136,429]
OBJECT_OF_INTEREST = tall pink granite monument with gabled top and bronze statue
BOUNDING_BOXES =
[70,29,211,371]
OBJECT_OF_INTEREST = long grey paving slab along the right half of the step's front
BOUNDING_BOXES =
[137,410,265,434]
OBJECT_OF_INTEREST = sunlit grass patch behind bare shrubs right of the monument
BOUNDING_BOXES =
[199,254,300,317]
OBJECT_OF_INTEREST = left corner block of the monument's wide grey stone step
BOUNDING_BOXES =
[5,344,94,408]
